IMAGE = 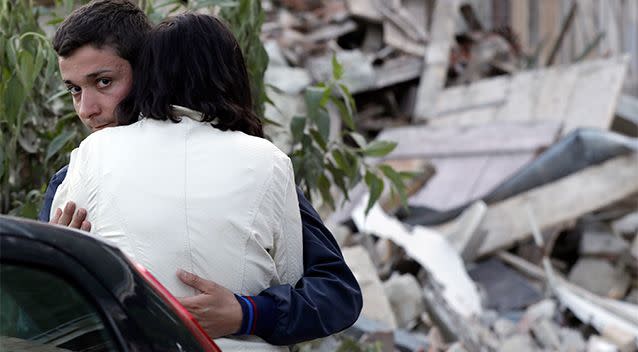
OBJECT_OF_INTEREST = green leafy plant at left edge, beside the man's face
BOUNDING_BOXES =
[0,0,84,217]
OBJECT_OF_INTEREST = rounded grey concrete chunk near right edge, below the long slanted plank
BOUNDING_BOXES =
[568,257,631,299]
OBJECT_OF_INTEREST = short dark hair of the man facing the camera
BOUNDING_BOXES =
[53,0,151,65]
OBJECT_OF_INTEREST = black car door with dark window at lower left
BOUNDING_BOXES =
[0,235,150,352]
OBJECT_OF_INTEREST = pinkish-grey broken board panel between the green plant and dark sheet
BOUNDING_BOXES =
[378,121,560,210]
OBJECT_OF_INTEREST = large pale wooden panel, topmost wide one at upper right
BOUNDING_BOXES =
[429,56,628,135]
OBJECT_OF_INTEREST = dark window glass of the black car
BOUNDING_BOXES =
[0,263,118,352]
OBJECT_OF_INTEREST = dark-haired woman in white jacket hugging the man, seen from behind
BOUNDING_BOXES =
[52,13,303,351]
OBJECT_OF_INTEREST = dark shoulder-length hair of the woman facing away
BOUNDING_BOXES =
[117,13,264,137]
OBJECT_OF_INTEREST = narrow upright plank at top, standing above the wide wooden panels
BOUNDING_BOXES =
[412,0,459,121]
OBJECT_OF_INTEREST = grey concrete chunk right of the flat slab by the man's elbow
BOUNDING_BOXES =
[383,274,425,329]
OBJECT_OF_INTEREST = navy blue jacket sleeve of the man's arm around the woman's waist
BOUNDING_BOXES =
[244,189,363,345]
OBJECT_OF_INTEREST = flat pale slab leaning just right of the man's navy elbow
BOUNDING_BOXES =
[342,246,397,330]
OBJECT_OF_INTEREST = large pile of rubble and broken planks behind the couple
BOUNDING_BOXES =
[263,0,638,352]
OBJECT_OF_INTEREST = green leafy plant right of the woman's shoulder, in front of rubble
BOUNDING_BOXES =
[290,55,412,213]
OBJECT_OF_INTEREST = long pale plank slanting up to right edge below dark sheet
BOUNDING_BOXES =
[479,153,638,255]
